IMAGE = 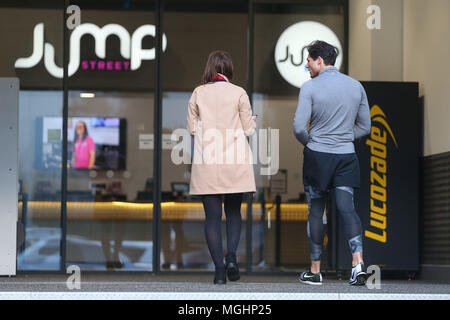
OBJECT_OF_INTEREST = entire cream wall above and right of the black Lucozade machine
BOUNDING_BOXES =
[349,0,450,156]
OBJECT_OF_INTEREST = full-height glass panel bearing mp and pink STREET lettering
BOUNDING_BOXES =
[67,1,155,271]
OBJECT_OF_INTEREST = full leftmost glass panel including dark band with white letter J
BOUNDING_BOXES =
[0,1,63,270]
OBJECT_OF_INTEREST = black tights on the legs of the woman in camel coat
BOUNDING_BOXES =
[202,193,242,268]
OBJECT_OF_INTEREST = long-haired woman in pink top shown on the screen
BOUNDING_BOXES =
[72,121,95,169]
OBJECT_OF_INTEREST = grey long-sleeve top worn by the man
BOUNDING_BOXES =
[294,67,371,154]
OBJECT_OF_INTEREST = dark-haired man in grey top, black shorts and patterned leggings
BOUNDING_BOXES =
[294,41,371,285]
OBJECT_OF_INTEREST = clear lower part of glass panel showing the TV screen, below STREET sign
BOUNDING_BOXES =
[67,91,154,271]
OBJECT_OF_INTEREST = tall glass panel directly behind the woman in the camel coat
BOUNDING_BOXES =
[161,1,248,270]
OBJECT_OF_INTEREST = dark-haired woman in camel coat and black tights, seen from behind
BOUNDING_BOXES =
[187,51,256,284]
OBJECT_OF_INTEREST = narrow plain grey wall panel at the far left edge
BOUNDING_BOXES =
[0,78,19,276]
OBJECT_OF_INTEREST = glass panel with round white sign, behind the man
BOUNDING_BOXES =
[252,4,346,271]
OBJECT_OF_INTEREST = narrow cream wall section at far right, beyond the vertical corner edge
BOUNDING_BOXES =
[403,0,450,156]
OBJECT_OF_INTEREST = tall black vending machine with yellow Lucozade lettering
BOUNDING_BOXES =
[331,81,423,275]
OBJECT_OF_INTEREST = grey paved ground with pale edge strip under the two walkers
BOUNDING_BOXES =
[0,274,450,300]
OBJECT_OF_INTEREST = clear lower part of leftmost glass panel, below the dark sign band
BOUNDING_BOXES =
[17,90,62,270]
